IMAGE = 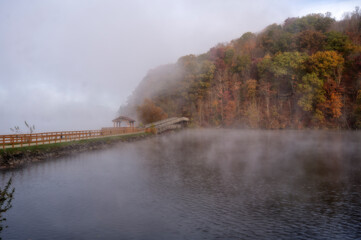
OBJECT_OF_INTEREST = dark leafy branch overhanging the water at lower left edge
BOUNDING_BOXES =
[0,178,15,240]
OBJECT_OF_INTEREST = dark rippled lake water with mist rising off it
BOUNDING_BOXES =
[0,130,361,239]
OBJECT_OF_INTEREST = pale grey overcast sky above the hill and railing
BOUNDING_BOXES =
[0,0,360,134]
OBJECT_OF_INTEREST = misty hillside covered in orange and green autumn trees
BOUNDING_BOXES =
[121,8,361,129]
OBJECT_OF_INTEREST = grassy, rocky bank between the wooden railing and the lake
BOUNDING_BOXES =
[0,133,154,171]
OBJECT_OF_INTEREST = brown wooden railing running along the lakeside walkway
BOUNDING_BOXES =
[0,127,144,149]
